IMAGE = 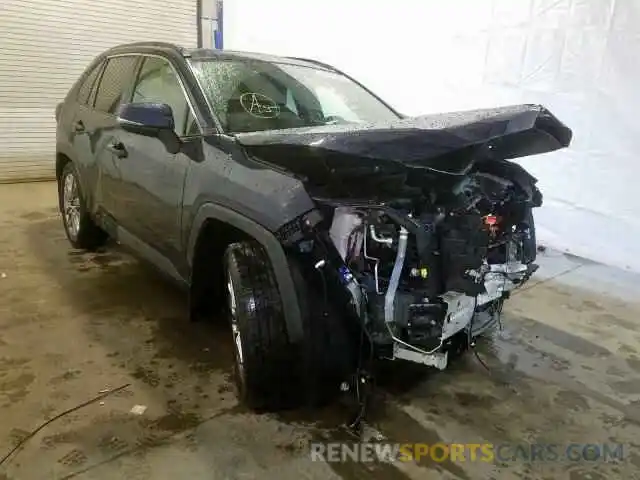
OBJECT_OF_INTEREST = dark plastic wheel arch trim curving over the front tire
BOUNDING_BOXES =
[187,203,303,343]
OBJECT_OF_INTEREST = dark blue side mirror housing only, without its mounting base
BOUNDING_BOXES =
[118,103,174,136]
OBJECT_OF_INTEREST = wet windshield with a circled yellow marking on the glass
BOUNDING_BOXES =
[192,60,398,132]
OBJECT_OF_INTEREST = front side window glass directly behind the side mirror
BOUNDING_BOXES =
[131,57,198,136]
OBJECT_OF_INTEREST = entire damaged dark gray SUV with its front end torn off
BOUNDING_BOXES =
[56,43,572,409]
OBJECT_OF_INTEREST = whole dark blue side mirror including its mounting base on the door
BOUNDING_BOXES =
[118,103,180,154]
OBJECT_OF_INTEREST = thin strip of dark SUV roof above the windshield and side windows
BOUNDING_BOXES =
[105,42,335,70]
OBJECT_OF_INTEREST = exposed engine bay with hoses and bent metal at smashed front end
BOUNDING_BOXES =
[316,163,541,369]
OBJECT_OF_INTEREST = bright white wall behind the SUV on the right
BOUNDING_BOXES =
[224,0,640,271]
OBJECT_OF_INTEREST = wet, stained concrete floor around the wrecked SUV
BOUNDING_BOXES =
[0,183,640,480]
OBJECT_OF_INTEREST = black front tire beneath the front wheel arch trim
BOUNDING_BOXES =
[224,241,302,410]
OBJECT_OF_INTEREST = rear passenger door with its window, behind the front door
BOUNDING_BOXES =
[88,55,140,225]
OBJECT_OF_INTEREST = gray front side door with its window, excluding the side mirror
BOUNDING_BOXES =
[119,55,200,266]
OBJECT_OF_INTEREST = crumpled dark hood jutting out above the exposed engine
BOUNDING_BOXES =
[235,105,572,173]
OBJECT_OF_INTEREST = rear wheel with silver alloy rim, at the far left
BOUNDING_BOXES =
[58,162,107,250]
